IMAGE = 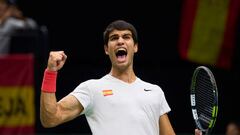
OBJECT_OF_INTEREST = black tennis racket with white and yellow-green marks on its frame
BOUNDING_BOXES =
[190,66,218,135]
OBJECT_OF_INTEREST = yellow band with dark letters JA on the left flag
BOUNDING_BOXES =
[0,86,35,127]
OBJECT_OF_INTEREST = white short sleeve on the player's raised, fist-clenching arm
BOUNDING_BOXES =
[70,82,92,114]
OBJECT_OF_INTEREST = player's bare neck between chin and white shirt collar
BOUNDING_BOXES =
[110,67,136,83]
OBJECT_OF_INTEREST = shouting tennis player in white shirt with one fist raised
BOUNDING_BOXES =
[40,20,200,135]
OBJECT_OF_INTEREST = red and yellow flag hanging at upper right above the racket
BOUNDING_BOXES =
[179,0,240,69]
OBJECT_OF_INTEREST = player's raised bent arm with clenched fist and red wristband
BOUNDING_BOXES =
[40,51,83,128]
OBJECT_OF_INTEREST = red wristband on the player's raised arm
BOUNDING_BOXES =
[42,69,57,93]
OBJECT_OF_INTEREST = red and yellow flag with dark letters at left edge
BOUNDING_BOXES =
[0,54,35,135]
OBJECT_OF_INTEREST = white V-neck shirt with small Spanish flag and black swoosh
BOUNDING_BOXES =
[70,74,170,135]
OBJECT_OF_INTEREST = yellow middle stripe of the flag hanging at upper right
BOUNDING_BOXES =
[188,0,229,65]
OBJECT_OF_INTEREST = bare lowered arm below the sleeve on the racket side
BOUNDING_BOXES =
[159,114,175,135]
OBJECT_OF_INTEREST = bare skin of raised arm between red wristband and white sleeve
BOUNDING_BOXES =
[40,92,83,127]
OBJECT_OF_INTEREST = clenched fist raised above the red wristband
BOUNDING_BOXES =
[47,51,67,71]
